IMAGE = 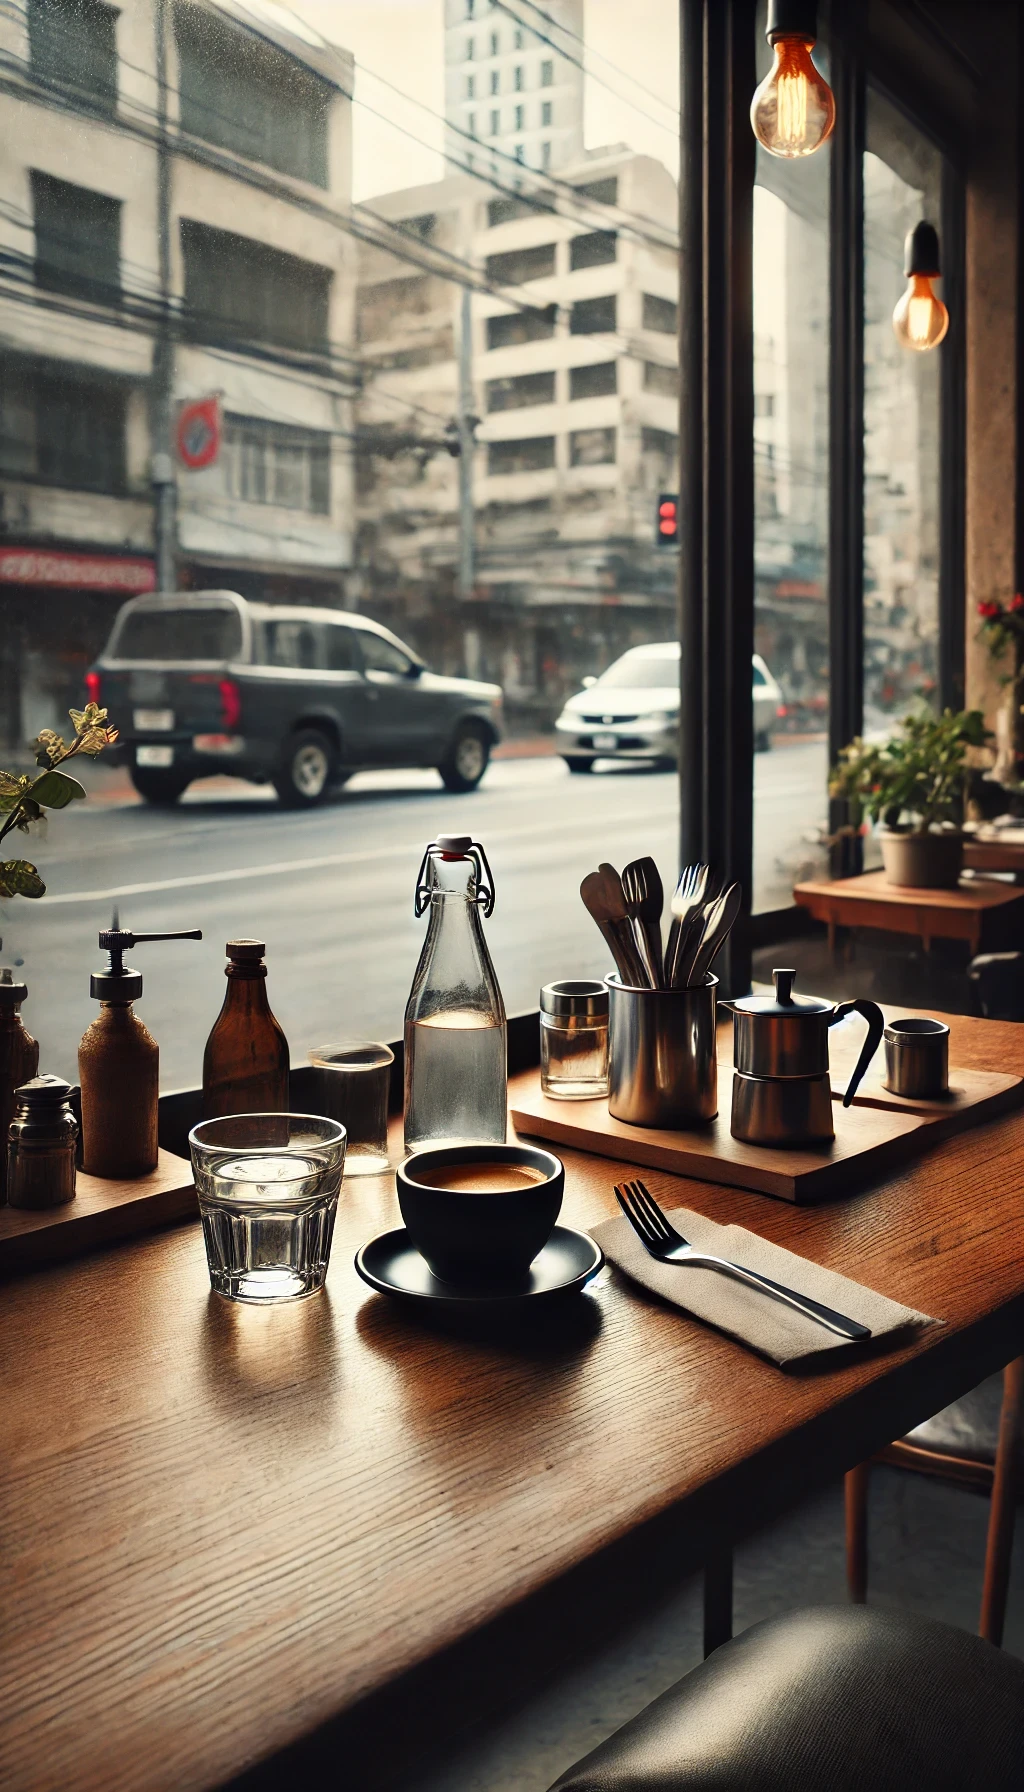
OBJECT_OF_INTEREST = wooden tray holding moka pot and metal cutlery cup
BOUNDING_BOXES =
[509,1064,940,1204]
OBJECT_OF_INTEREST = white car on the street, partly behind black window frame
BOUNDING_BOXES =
[554,642,784,772]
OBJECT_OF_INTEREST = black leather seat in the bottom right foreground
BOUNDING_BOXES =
[551,1606,1024,1792]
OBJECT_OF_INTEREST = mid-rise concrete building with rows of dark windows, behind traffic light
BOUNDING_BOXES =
[353,147,678,720]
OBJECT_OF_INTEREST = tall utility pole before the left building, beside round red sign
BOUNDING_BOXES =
[149,0,178,591]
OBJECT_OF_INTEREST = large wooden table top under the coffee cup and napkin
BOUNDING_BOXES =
[0,1018,1024,1792]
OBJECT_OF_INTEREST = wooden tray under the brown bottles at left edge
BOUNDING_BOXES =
[0,1150,199,1276]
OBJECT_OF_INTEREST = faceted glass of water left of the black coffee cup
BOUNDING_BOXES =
[188,1115,346,1301]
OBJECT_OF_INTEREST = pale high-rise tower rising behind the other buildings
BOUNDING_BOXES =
[445,0,583,179]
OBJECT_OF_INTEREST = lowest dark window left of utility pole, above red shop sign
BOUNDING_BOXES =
[0,357,129,493]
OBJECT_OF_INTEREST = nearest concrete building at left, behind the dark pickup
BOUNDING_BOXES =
[0,0,355,744]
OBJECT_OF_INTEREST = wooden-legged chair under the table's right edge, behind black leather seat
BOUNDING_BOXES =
[845,1357,1024,1643]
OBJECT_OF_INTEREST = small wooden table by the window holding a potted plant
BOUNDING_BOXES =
[793,871,1024,957]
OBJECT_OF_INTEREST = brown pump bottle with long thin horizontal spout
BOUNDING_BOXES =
[79,926,203,1181]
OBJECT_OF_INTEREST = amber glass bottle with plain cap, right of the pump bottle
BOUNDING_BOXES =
[203,939,289,1120]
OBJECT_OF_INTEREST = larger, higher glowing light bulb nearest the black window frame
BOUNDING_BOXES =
[750,0,836,159]
